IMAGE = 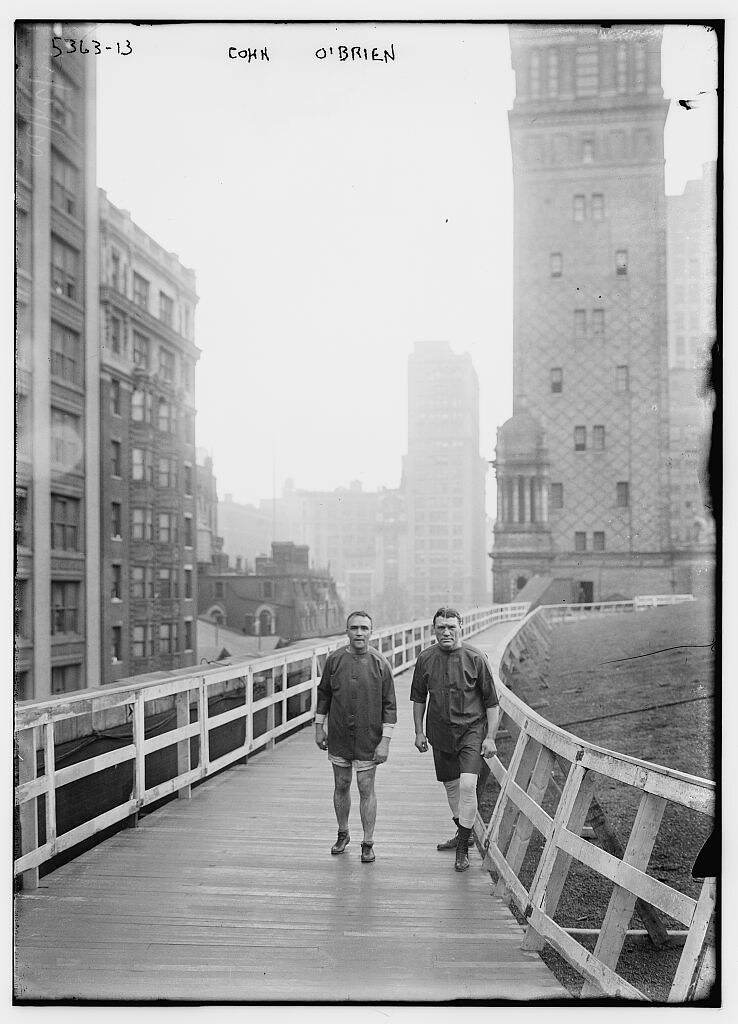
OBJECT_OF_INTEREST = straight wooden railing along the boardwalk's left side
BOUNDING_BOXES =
[14,603,528,888]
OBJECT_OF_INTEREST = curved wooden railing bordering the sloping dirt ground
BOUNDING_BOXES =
[475,599,715,1002]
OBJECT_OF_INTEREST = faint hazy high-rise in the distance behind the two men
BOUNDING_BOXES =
[402,341,488,617]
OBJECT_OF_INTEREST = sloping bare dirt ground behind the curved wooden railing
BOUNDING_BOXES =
[480,601,715,1001]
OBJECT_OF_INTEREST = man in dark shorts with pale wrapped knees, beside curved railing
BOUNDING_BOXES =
[410,607,500,871]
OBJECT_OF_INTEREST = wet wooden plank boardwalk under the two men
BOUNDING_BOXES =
[15,630,568,1004]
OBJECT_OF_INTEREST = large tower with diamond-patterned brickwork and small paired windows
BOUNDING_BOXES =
[492,26,712,601]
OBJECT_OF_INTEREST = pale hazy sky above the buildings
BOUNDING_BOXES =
[89,24,717,511]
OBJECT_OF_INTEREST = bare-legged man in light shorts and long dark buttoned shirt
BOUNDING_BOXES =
[315,611,397,864]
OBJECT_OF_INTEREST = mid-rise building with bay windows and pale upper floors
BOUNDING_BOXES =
[99,190,200,682]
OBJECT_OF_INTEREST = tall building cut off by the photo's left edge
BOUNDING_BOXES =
[14,23,102,699]
